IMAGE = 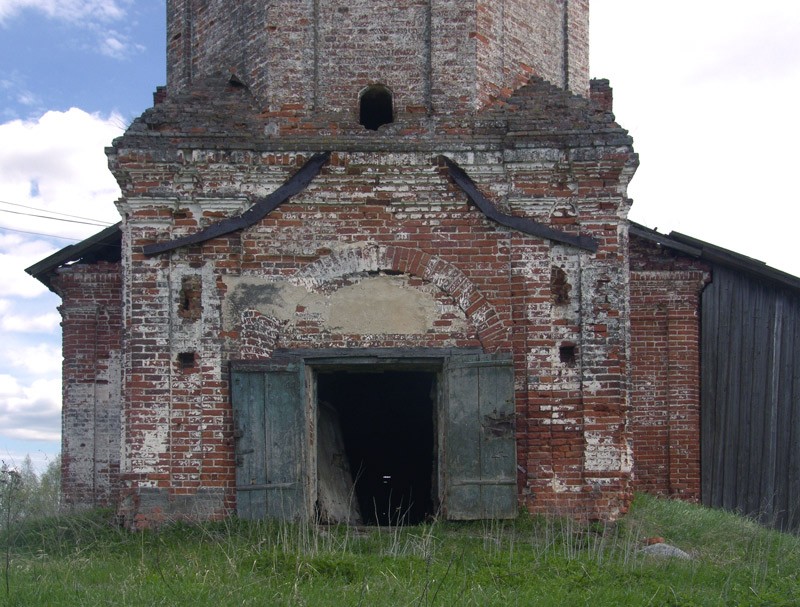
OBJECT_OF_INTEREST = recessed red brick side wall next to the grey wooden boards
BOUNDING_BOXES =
[630,238,709,500]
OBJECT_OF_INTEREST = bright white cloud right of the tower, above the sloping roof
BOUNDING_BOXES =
[591,0,800,274]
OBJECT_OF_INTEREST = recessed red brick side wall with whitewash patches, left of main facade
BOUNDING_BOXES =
[53,262,122,508]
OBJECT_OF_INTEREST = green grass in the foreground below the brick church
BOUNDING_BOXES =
[0,496,800,607]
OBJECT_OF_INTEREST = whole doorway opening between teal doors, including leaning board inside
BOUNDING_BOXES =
[317,370,436,525]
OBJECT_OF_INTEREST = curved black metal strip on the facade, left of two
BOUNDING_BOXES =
[143,152,331,255]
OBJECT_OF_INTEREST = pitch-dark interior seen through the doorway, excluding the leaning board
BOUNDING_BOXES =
[317,370,436,525]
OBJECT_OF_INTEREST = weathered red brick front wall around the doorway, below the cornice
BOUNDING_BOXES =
[108,121,630,524]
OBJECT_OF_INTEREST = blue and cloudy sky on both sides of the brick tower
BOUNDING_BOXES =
[0,0,800,469]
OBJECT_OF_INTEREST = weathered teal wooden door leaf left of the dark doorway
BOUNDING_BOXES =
[231,361,308,520]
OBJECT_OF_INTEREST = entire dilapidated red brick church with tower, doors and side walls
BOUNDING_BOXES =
[29,0,711,526]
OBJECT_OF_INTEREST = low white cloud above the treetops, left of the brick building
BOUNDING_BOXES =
[0,374,61,441]
